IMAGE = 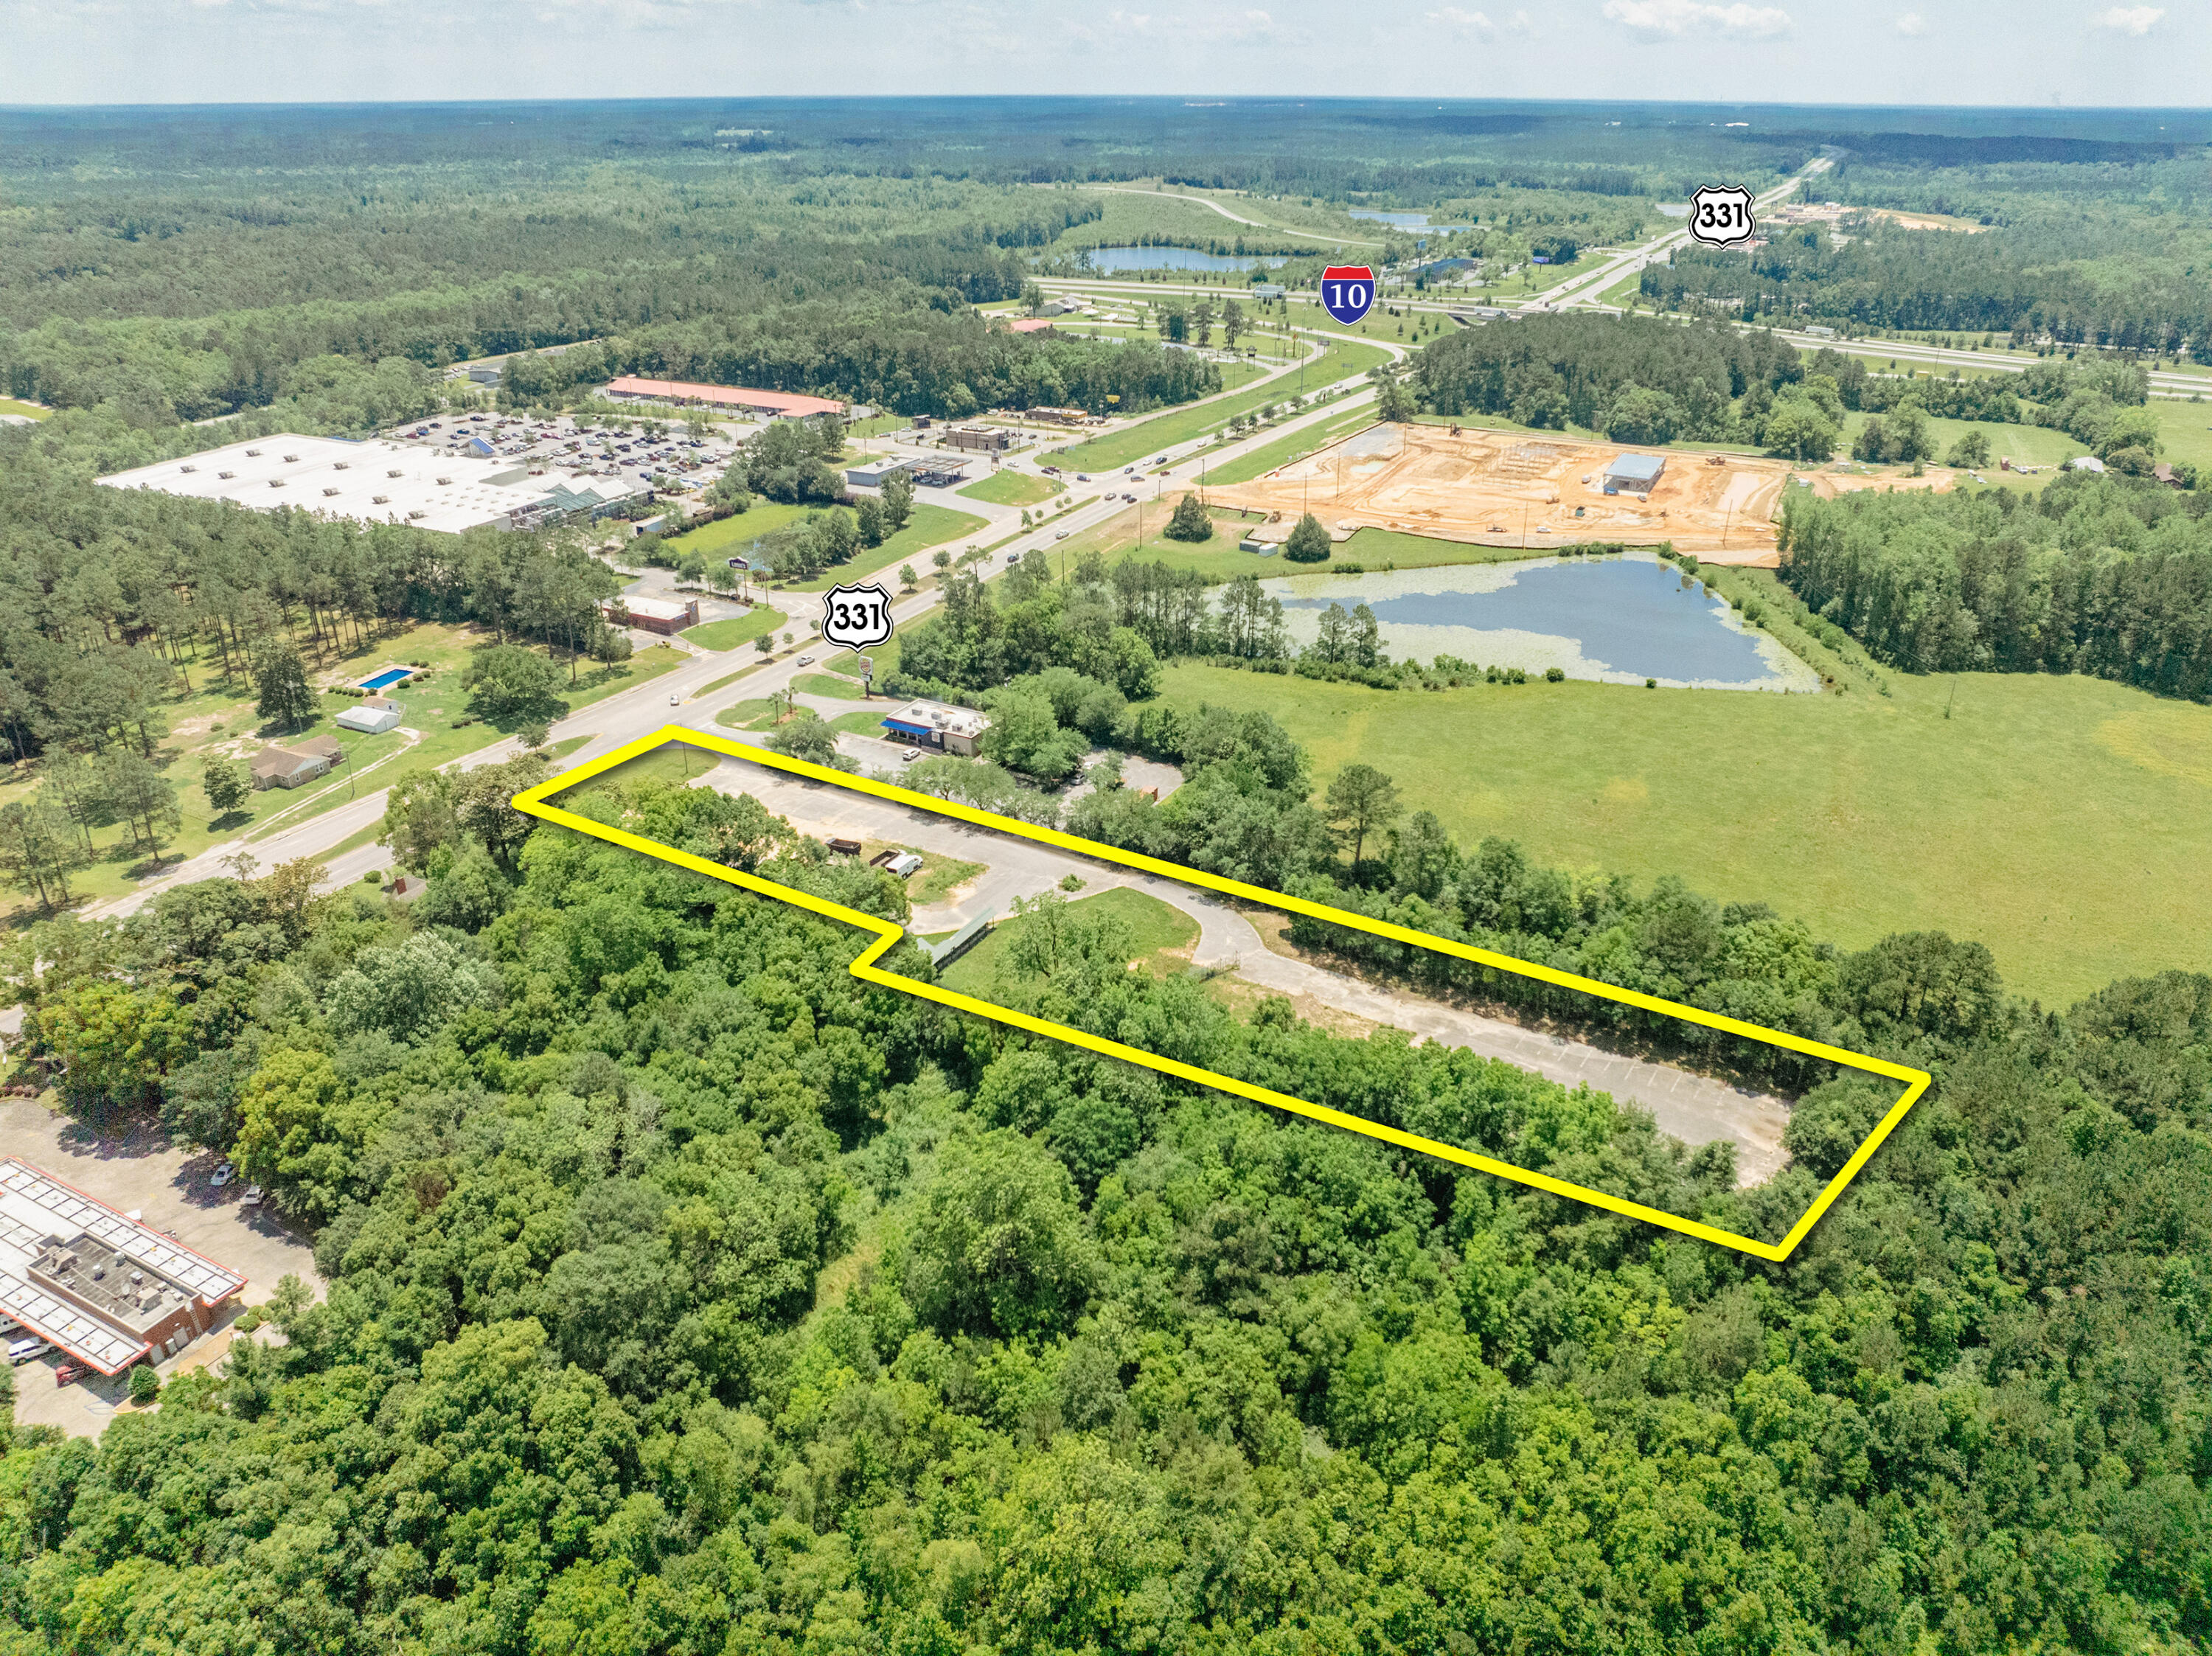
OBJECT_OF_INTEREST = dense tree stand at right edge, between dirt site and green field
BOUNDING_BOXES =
[1781,476,2212,701]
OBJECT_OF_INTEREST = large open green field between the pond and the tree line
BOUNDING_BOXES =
[1161,666,2212,1006]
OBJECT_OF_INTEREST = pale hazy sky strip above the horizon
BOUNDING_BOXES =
[0,0,2212,108]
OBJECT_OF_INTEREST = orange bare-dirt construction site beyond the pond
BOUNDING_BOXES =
[1206,425,1944,568]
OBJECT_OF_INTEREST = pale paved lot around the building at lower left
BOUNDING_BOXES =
[0,1099,323,1437]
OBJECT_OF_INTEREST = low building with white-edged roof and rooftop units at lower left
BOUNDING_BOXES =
[0,1156,246,1375]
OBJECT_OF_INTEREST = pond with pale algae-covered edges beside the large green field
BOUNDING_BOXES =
[1261,553,1820,690]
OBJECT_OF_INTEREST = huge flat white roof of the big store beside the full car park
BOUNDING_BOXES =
[100,431,635,533]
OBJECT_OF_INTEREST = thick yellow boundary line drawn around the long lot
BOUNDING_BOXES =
[513,726,1931,1262]
